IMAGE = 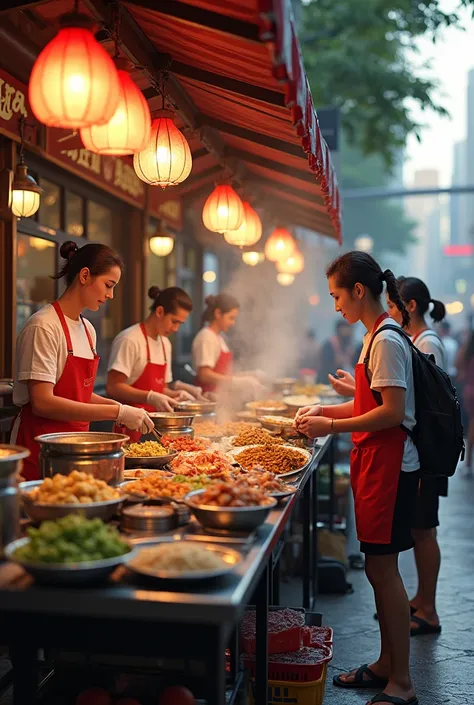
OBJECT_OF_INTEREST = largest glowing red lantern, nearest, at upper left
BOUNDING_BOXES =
[29,13,119,129]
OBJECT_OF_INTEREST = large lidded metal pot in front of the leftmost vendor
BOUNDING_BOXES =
[35,431,130,485]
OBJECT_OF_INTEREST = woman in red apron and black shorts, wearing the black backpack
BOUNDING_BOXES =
[295,252,419,705]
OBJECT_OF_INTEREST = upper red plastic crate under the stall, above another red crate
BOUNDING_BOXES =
[240,608,305,654]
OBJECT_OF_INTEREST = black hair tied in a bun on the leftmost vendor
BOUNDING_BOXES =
[51,240,124,286]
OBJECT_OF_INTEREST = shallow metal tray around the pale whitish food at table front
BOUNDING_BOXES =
[126,536,242,583]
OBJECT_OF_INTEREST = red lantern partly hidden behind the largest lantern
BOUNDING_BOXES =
[81,59,151,156]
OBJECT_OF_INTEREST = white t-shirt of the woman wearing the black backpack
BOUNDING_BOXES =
[359,319,420,472]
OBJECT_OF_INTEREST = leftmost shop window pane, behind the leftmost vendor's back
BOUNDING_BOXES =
[16,233,56,332]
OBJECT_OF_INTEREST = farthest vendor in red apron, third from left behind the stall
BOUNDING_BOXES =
[192,292,264,398]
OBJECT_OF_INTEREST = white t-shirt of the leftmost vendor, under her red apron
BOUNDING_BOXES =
[13,304,97,406]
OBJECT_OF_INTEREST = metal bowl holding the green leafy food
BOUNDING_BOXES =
[5,538,137,585]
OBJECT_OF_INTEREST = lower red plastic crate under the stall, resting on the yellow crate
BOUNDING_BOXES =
[244,644,332,683]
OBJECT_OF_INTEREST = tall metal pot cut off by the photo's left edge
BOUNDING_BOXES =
[0,444,30,558]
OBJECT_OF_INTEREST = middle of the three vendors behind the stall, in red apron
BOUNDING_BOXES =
[107,286,202,441]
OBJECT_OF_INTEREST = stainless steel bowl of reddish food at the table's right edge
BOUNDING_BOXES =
[184,490,277,531]
